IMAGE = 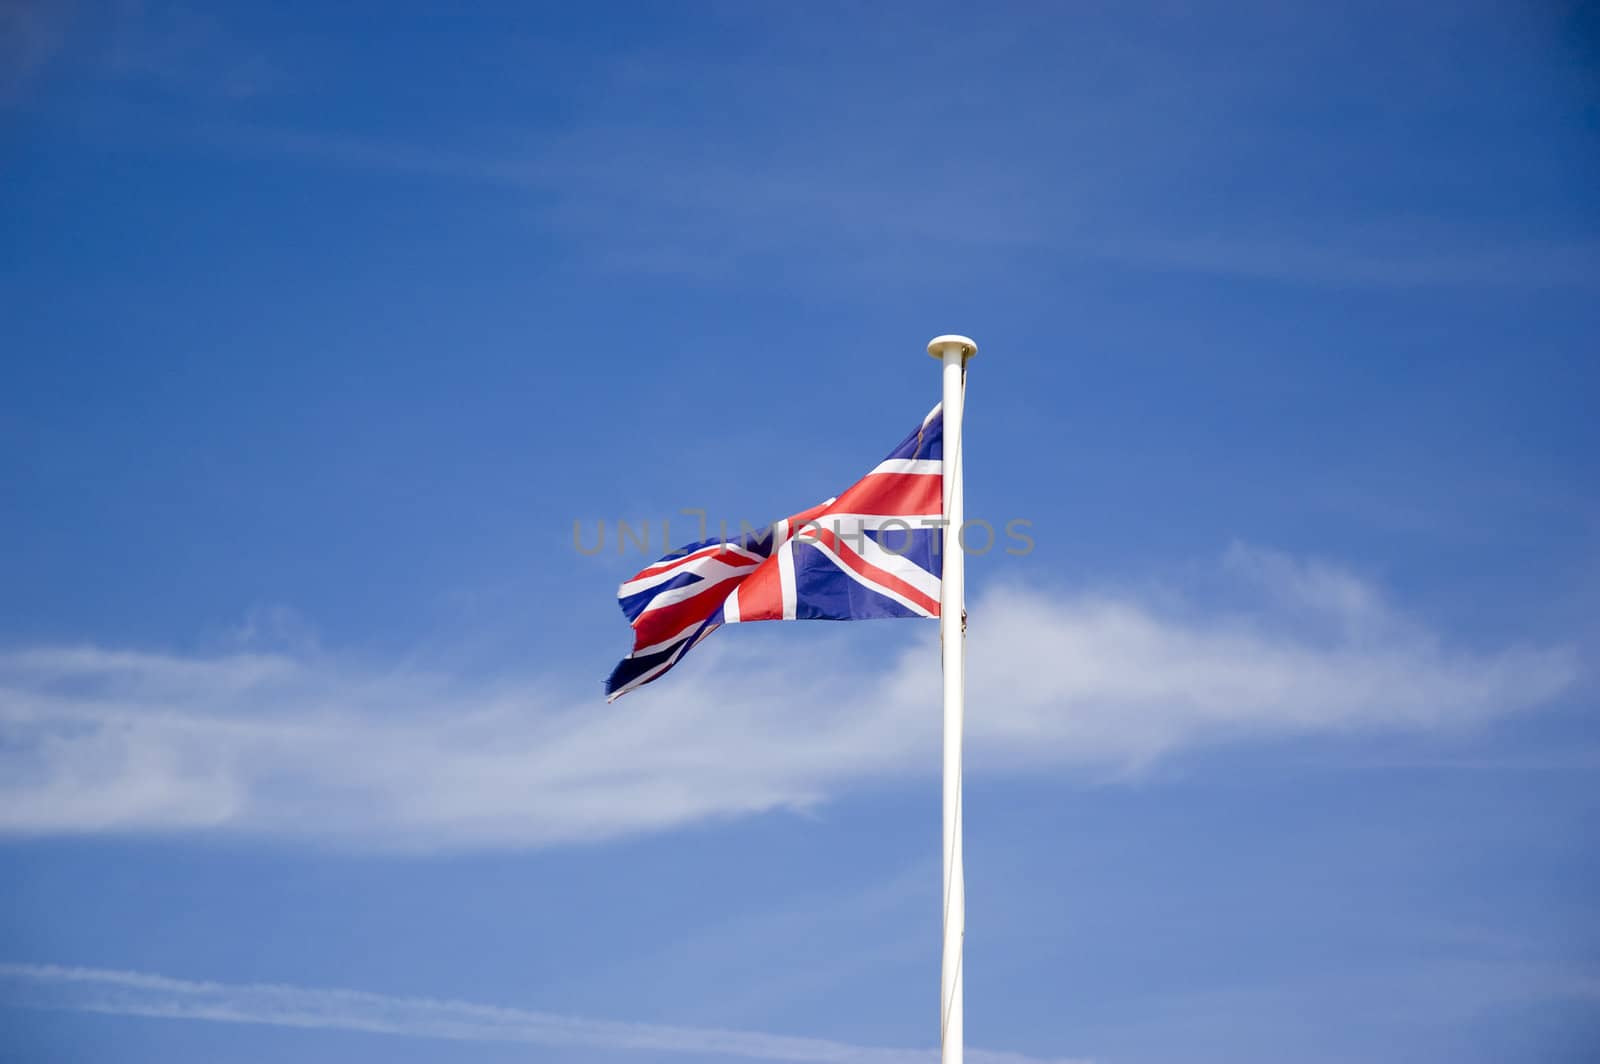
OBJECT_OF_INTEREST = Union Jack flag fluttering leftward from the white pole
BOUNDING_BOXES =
[605,406,944,701]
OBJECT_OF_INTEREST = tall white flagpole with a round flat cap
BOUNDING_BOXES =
[928,336,978,1064]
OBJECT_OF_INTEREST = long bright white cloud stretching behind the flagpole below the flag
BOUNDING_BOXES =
[0,547,1578,850]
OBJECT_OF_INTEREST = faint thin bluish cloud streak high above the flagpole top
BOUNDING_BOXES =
[190,114,1600,290]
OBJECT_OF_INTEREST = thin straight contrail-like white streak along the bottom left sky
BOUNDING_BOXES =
[0,963,1088,1064]
